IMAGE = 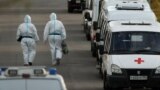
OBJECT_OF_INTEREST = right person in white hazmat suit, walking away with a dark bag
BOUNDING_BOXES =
[44,13,66,65]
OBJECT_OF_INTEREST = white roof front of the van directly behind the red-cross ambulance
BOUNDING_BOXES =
[106,7,157,21]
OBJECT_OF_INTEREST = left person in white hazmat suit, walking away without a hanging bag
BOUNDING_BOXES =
[16,15,39,66]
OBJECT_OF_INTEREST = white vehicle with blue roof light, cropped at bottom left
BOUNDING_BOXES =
[0,66,67,90]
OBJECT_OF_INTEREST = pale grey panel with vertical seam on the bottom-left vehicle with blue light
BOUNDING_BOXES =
[0,79,63,90]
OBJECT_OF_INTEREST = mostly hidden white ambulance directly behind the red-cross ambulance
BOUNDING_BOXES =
[91,1,157,67]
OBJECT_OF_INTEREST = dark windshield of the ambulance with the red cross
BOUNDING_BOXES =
[110,32,160,54]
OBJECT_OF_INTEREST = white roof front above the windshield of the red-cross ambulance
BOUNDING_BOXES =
[109,20,160,33]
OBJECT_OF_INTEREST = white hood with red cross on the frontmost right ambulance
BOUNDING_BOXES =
[111,55,160,69]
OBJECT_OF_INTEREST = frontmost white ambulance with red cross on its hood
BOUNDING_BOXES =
[101,21,160,90]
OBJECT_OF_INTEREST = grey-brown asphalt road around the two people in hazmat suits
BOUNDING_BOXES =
[0,0,103,90]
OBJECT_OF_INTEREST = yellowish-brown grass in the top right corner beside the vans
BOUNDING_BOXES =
[151,0,160,22]
